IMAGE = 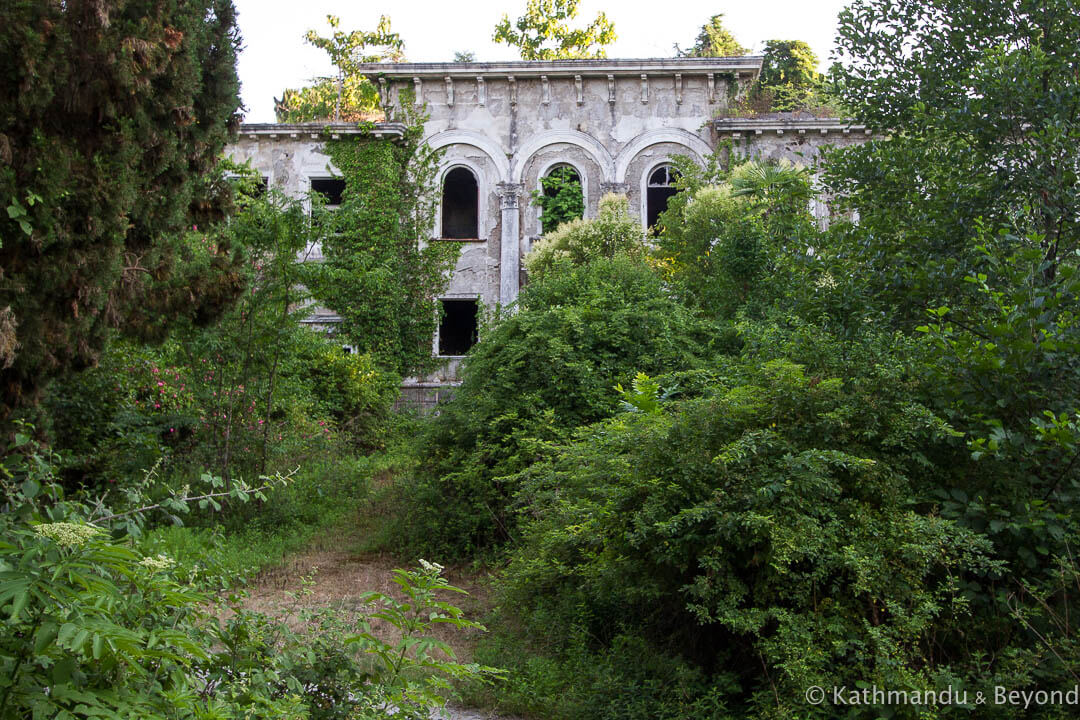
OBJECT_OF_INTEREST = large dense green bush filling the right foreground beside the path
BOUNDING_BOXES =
[486,349,1003,718]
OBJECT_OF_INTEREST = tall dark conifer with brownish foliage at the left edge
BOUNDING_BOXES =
[0,0,240,415]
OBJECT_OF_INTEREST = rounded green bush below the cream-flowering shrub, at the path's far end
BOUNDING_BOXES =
[397,253,710,556]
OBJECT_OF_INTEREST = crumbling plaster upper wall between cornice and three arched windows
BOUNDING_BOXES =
[390,74,728,205]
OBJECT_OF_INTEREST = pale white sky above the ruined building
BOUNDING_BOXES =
[234,0,847,122]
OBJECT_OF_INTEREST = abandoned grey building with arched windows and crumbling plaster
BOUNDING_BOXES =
[228,56,869,406]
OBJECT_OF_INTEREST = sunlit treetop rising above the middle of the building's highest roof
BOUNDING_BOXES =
[492,0,616,60]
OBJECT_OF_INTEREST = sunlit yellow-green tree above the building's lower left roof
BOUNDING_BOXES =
[274,15,405,122]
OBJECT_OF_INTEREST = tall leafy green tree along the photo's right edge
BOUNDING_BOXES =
[821,0,1080,587]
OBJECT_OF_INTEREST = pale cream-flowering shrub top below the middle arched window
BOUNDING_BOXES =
[525,193,645,280]
